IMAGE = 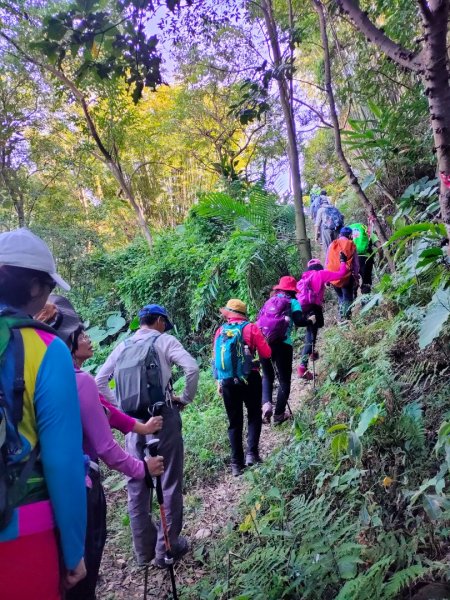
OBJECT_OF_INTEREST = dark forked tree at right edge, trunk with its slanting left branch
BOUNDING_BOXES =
[337,0,450,246]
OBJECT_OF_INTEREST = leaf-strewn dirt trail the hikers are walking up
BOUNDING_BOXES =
[97,375,312,600]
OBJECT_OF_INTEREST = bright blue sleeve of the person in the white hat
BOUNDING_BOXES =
[34,338,86,569]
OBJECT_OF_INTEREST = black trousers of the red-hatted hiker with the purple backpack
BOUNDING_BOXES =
[261,342,294,415]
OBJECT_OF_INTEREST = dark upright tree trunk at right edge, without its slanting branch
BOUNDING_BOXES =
[419,0,450,238]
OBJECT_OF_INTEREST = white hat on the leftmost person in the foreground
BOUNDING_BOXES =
[0,227,70,291]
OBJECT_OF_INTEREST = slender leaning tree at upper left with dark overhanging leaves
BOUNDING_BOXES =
[0,0,189,246]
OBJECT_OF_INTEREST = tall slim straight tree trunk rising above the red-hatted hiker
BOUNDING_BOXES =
[261,0,311,265]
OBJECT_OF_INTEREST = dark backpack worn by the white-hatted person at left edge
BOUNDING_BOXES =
[0,308,57,531]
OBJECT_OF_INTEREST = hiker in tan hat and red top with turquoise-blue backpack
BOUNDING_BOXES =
[213,299,271,477]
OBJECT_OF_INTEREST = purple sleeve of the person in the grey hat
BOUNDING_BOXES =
[77,373,145,479]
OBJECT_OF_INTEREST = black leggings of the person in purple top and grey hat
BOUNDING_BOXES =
[66,469,106,600]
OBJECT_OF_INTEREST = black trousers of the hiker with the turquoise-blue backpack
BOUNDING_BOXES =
[222,371,262,466]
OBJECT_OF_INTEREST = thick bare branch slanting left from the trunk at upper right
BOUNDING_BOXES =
[337,0,422,71]
